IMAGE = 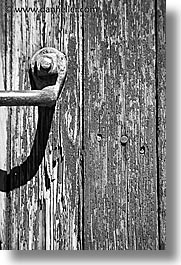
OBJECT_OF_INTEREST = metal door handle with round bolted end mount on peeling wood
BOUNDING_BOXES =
[0,47,67,107]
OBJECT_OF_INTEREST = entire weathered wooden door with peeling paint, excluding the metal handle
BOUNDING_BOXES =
[0,0,166,250]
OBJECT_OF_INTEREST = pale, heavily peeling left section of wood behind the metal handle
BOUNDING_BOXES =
[1,0,82,250]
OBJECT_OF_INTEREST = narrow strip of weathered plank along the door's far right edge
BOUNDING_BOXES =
[156,0,166,250]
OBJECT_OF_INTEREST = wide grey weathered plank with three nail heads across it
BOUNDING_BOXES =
[84,0,158,250]
